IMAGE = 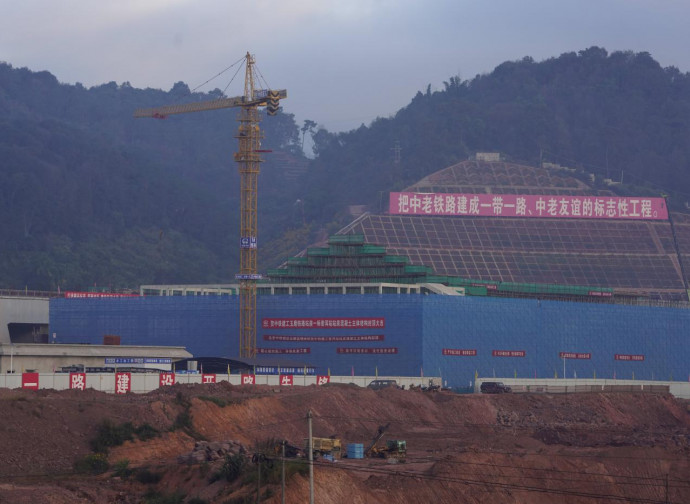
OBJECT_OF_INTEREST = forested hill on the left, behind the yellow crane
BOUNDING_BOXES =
[0,63,306,290]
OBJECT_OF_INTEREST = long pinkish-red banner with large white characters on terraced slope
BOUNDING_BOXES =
[388,192,668,220]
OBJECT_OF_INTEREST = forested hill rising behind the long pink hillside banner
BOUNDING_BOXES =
[305,47,690,222]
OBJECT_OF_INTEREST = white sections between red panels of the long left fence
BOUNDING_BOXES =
[0,373,441,394]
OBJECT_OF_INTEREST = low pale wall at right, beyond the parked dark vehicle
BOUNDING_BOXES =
[474,378,690,399]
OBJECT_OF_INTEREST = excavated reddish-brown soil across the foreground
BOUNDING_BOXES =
[0,382,690,504]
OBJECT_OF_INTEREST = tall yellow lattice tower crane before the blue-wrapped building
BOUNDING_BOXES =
[134,53,287,358]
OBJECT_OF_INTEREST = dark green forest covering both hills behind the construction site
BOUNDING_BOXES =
[0,47,690,289]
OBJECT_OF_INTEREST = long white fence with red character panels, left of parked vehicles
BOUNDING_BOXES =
[0,373,441,394]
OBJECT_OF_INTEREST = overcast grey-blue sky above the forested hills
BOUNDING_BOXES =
[0,0,690,131]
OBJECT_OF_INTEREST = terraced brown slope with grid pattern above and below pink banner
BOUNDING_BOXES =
[339,160,690,300]
